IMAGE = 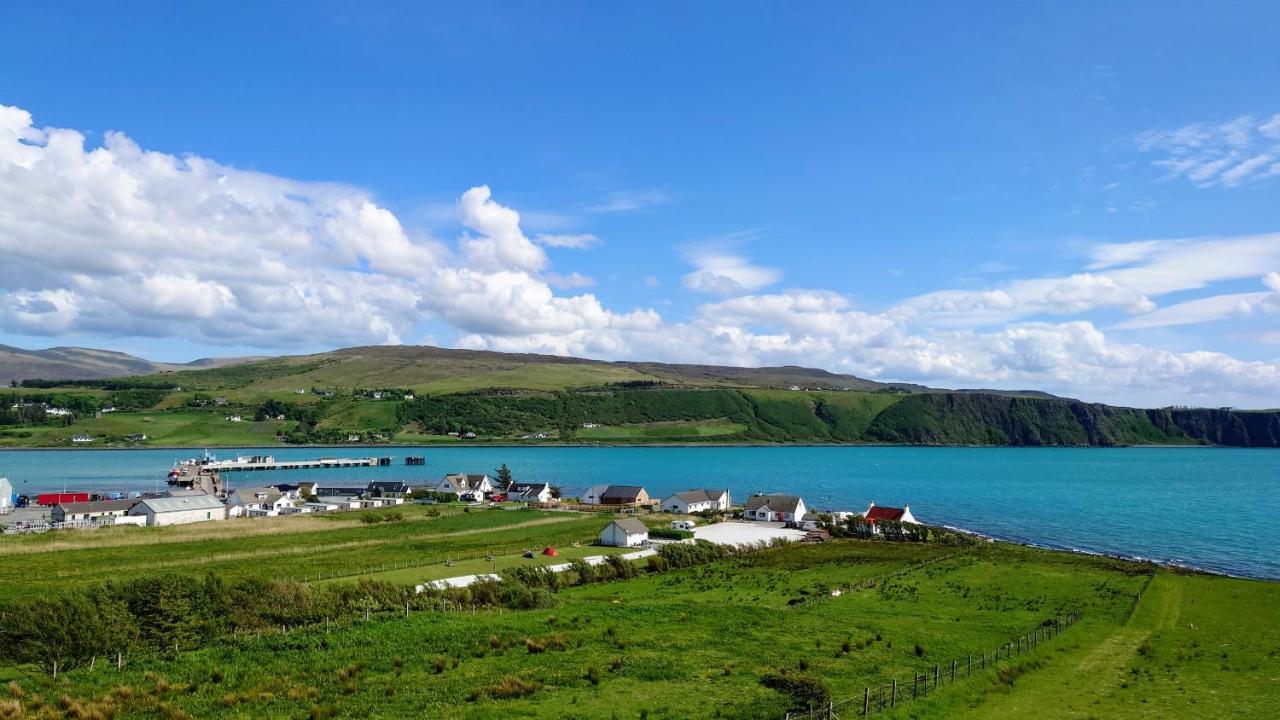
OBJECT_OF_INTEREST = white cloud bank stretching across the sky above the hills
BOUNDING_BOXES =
[0,99,1280,405]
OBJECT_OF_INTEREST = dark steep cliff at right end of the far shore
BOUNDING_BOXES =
[867,393,1280,447]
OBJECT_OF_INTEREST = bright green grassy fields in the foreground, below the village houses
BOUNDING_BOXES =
[0,511,1280,720]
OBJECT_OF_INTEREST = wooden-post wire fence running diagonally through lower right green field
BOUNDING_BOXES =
[786,611,1080,720]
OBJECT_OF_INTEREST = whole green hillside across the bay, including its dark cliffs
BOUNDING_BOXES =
[0,347,1280,447]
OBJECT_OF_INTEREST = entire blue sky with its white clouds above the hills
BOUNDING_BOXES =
[0,3,1280,406]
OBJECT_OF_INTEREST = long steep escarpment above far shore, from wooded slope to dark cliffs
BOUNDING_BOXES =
[399,388,1280,447]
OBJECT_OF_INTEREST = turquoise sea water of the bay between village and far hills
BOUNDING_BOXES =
[0,447,1280,579]
